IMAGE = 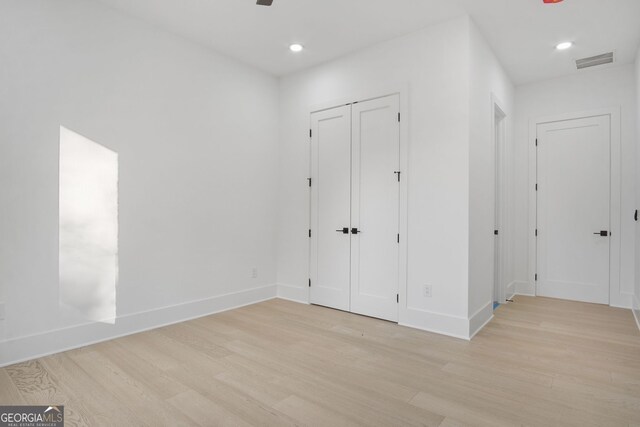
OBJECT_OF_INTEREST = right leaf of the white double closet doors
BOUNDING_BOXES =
[351,95,400,321]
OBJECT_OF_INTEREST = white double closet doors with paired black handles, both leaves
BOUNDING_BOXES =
[310,95,400,321]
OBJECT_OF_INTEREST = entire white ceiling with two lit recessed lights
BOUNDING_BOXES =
[95,0,640,84]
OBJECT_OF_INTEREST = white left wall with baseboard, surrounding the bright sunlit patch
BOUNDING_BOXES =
[0,0,278,365]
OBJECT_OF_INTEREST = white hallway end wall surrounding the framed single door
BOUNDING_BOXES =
[511,65,636,307]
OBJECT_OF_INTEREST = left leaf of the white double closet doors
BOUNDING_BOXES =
[310,106,351,310]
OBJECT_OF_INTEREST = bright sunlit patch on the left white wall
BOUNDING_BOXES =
[59,126,118,323]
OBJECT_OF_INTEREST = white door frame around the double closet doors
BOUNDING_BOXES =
[304,84,410,324]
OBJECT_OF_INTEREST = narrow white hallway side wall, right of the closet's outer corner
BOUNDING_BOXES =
[469,23,514,322]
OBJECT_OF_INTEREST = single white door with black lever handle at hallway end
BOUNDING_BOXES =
[537,115,611,304]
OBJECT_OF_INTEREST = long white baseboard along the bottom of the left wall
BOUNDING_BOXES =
[0,285,277,367]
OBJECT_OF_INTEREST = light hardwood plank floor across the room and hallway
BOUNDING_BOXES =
[0,297,640,426]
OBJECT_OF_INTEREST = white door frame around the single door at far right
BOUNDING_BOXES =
[528,107,622,306]
